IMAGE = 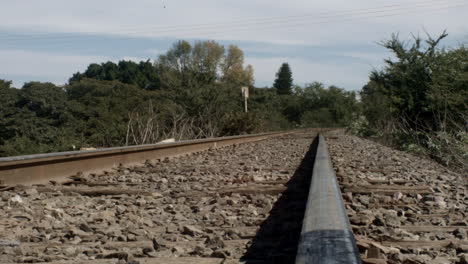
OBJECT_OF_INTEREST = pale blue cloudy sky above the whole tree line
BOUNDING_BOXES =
[0,0,468,90]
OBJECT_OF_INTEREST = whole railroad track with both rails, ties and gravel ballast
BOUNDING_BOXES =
[0,130,466,264]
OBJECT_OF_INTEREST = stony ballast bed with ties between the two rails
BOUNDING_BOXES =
[0,132,314,264]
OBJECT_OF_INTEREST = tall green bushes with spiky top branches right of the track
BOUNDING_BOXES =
[361,32,468,171]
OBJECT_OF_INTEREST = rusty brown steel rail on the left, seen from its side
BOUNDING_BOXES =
[0,130,301,185]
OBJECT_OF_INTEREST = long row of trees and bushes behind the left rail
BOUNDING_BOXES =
[0,41,359,156]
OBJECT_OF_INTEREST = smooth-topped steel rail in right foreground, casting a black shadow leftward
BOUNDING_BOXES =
[296,135,362,264]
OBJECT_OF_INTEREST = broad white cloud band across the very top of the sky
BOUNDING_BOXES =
[0,0,468,44]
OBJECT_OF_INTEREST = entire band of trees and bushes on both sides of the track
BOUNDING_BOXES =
[0,32,462,171]
